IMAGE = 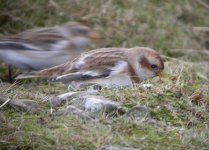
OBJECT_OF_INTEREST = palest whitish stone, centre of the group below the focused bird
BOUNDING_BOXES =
[73,95,121,113]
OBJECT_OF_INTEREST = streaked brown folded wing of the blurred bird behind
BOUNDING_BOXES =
[0,27,69,51]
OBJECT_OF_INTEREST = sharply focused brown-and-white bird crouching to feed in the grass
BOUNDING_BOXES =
[20,47,164,88]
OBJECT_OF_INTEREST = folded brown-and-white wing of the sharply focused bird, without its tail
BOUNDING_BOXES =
[56,48,128,81]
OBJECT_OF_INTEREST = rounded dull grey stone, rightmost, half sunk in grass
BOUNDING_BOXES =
[125,106,150,123]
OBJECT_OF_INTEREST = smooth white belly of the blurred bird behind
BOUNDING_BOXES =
[0,50,69,69]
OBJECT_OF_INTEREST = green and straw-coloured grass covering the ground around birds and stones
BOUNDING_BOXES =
[0,0,209,150]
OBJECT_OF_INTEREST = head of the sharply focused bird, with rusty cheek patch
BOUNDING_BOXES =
[128,47,164,81]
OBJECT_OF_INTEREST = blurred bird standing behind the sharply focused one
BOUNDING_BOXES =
[0,23,99,71]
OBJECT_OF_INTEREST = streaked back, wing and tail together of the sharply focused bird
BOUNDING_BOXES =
[15,48,126,78]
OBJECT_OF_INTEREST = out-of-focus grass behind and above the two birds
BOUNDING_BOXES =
[0,0,209,77]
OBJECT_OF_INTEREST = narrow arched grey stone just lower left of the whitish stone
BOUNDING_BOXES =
[52,105,95,122]
